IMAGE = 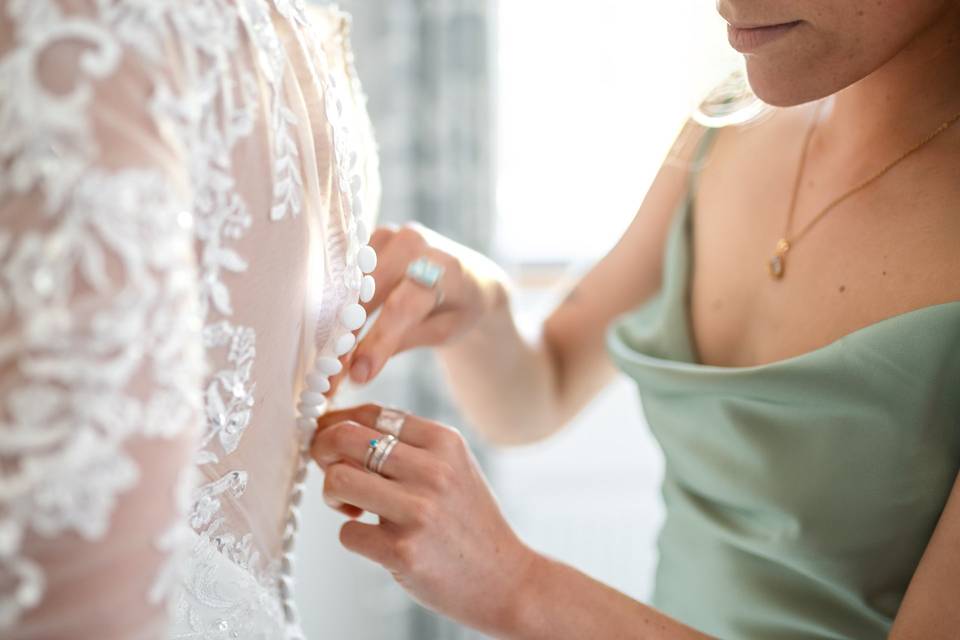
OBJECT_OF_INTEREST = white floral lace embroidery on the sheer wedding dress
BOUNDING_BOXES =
[0,0,375,640]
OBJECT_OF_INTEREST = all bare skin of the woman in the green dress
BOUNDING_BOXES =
[313,0,960,640]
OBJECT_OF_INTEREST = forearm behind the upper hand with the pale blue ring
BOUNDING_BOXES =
[439,294,564,444]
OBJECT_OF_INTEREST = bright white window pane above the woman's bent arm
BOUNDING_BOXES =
[496,0,737,266]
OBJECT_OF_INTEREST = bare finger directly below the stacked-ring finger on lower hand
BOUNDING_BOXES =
[323,462,419,524]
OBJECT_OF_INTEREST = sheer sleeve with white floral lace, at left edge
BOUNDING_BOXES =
[0,0,204,640]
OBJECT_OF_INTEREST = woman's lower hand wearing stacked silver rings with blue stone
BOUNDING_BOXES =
[312,405,539,637]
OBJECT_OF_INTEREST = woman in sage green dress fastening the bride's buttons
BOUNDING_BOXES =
[312,0,960,640]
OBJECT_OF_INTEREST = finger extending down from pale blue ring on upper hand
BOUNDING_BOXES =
[350,279,437,384]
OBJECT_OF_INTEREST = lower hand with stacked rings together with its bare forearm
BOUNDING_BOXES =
[312,405,705,639]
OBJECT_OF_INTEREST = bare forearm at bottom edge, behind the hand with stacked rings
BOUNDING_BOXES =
[502,555,709,640]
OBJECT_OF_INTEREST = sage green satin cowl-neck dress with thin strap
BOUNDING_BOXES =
[608,129,960,640]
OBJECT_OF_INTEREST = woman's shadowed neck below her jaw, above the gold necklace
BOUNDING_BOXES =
[818,9,960,154]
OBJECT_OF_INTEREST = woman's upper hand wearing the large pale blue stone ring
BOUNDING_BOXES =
[342,225,507,388]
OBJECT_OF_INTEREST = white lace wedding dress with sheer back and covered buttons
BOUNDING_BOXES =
[0,0,379,640]
